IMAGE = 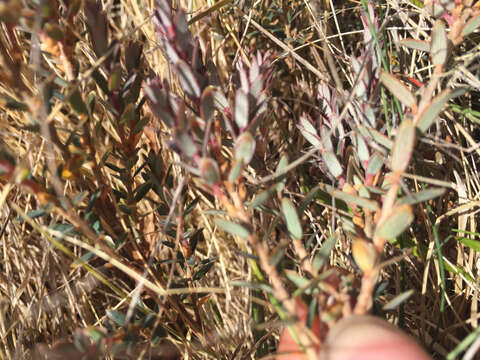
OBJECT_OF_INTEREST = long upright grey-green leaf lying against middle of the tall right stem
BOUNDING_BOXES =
[392,119,415,173]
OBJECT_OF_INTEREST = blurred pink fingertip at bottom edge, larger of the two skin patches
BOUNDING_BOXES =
[319,315,431,360]
